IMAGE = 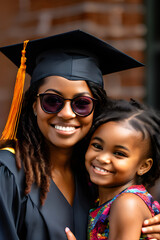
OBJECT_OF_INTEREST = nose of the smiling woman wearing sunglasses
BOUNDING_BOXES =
[57,100,76,119]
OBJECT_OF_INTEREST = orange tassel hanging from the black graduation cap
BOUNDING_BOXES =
[0,40,29,140]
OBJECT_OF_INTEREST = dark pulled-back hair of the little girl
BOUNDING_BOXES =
[90,99,160,187]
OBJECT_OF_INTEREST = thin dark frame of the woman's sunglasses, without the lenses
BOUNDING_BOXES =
[37,93,97,117]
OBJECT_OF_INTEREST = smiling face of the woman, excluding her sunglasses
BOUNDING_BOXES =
[33,76,93,148]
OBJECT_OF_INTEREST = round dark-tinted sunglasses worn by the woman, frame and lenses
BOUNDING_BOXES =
[37,93,96,117]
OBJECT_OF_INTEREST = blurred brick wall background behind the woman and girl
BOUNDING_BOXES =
[0,0,160,198]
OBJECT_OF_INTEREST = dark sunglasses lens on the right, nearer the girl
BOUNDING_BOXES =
[72,96,93,116]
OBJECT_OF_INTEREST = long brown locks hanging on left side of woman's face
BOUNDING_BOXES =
[16,80,50,204]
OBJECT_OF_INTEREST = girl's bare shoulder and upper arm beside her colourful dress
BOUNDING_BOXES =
[109,188,151,239]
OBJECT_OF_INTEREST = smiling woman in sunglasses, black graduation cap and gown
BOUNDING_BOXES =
[0,31,159,240]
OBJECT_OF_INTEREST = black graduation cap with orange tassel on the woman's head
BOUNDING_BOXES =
[0,30,143,139]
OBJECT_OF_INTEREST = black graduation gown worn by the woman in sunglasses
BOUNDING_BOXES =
[0,150,90,240]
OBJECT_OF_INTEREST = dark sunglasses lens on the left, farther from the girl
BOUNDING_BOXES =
[42,94,64,113]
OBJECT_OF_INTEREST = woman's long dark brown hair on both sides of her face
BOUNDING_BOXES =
[0,79,107,204]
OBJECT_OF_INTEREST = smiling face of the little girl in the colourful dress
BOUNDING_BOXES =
[85,121,150,190]
